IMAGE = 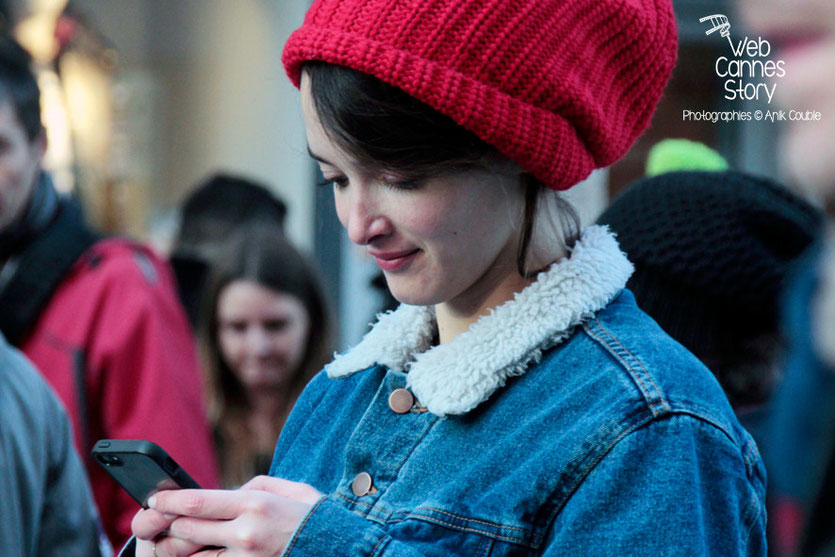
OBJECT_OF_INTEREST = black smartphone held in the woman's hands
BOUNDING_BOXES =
[93,439,200,509]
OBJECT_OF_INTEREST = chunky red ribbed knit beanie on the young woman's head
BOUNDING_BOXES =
[283,0,676,190]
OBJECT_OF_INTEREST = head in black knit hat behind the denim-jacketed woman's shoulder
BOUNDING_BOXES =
[598,171,821,412]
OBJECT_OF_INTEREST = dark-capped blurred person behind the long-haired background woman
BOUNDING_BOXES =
[170,173,287,330]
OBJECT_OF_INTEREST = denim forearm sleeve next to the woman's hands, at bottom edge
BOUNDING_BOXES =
[282,497,432,557]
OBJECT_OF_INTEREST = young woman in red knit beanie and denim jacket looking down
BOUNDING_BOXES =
[134,0,765,557]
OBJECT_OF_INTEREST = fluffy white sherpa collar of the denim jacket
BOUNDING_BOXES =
[325,226,633,416]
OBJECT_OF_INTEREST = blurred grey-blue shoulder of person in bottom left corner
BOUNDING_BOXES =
[0,333,113,557]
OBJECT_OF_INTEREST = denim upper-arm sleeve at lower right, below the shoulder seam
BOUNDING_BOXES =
[544,414,766,556]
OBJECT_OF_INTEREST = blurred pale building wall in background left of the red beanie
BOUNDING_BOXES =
[73,0,314,250]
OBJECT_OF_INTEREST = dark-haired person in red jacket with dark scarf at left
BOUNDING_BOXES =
[0,31,219,547]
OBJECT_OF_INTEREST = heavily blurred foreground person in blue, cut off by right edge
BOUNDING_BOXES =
[741,0,835,555]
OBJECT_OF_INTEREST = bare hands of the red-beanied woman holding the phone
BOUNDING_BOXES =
[132,476,322,557]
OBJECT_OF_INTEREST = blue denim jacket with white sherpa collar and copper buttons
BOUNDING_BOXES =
[270,227,766,557]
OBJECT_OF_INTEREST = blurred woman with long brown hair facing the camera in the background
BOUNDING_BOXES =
[200,223,332,488]
